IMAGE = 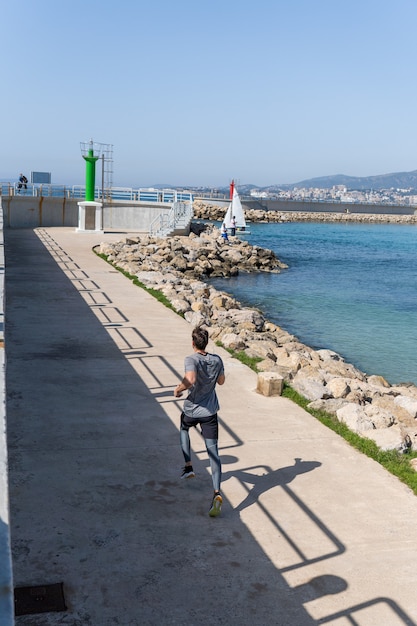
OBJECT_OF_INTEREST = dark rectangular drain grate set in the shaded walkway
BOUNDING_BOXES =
[14,583,67,615]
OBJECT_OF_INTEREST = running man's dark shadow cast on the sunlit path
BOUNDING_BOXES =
[222,457,321,512]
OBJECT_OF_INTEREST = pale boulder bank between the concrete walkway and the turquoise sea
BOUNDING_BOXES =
[95,229,417,452]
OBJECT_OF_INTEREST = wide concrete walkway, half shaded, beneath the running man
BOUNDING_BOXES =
[5,228,417,626]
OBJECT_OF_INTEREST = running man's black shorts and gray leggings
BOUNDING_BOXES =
[180,413,222,491]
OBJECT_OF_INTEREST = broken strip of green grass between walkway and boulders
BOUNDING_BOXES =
[95,246,417,495]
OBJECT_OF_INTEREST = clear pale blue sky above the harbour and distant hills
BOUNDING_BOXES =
[0,0,417,186]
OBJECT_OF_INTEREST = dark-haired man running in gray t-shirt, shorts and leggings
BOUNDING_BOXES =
[174,327,225,517]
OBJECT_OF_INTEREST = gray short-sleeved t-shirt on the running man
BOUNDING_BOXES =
[183,352,224,418]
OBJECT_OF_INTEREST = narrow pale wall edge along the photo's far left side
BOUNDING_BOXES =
[0,198,14,626]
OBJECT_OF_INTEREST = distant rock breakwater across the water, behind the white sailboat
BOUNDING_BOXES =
[193,200,417,224]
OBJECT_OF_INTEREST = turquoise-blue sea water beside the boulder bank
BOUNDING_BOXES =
[211,222,417,384]
